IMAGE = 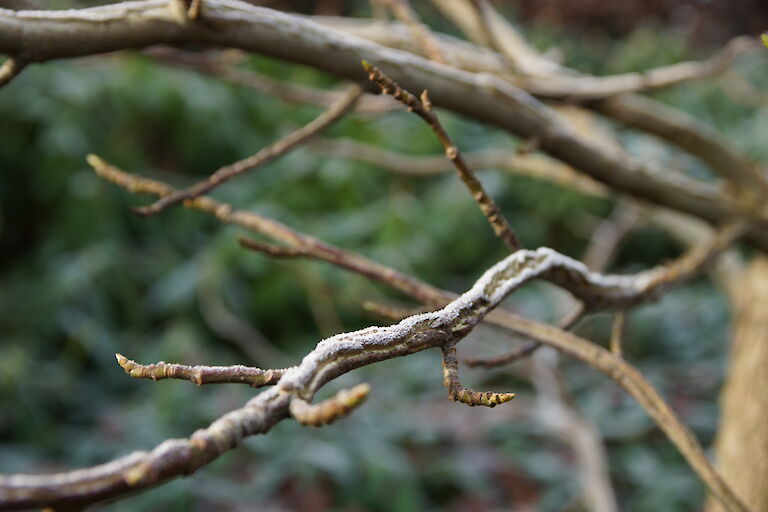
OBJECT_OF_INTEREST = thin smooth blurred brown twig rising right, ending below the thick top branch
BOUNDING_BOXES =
[135,85,363,216]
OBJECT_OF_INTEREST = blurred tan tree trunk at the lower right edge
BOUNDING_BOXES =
[707,256,768,512]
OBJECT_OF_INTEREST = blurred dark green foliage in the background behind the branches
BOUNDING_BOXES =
[0,2,768,511]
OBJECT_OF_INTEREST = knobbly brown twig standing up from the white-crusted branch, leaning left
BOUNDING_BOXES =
[363,61,521,252]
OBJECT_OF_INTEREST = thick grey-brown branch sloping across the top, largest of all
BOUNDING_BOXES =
[0,0,768,250]
